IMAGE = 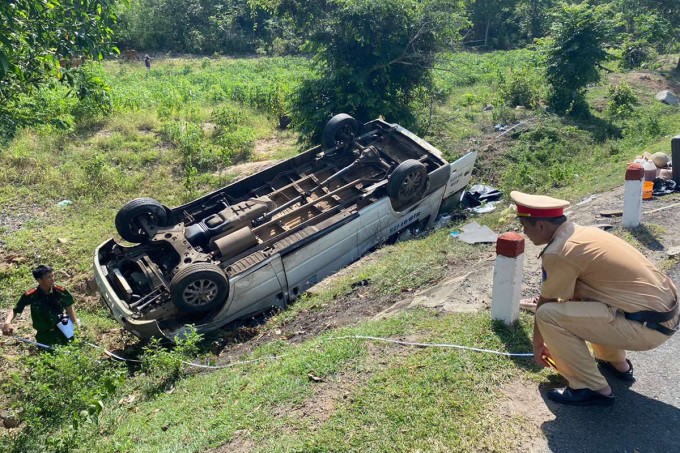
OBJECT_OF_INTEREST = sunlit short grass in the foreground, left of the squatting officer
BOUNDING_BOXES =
[65,311,534,452]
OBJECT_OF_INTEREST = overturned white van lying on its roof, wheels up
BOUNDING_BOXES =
[94,114,476,339]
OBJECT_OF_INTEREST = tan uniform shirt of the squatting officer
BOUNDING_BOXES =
[541,222,678,328]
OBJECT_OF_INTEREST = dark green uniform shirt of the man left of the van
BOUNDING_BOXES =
[14,285,73,346]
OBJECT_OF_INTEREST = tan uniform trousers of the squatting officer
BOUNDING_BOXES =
[536,301,670,390]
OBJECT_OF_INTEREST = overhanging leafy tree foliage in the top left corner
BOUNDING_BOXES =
[0,0,126,135]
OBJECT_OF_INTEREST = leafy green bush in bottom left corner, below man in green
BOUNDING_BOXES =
[2,339,126,451]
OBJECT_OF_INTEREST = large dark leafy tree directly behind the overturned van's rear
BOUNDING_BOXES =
[254,0,466,137]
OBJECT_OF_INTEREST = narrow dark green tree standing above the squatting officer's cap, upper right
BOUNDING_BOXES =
[542,2,613,115]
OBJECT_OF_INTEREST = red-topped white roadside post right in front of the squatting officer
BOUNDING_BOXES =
[491,233,524,324]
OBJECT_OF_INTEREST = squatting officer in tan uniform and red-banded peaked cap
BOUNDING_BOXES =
[510,191,680,406]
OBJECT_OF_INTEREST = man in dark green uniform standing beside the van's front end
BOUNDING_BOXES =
[2,265,80,346]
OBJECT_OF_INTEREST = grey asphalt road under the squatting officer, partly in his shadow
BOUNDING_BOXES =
[541,265,680,453]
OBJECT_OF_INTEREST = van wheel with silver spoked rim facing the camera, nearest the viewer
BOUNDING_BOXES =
[170,263,229,313]
